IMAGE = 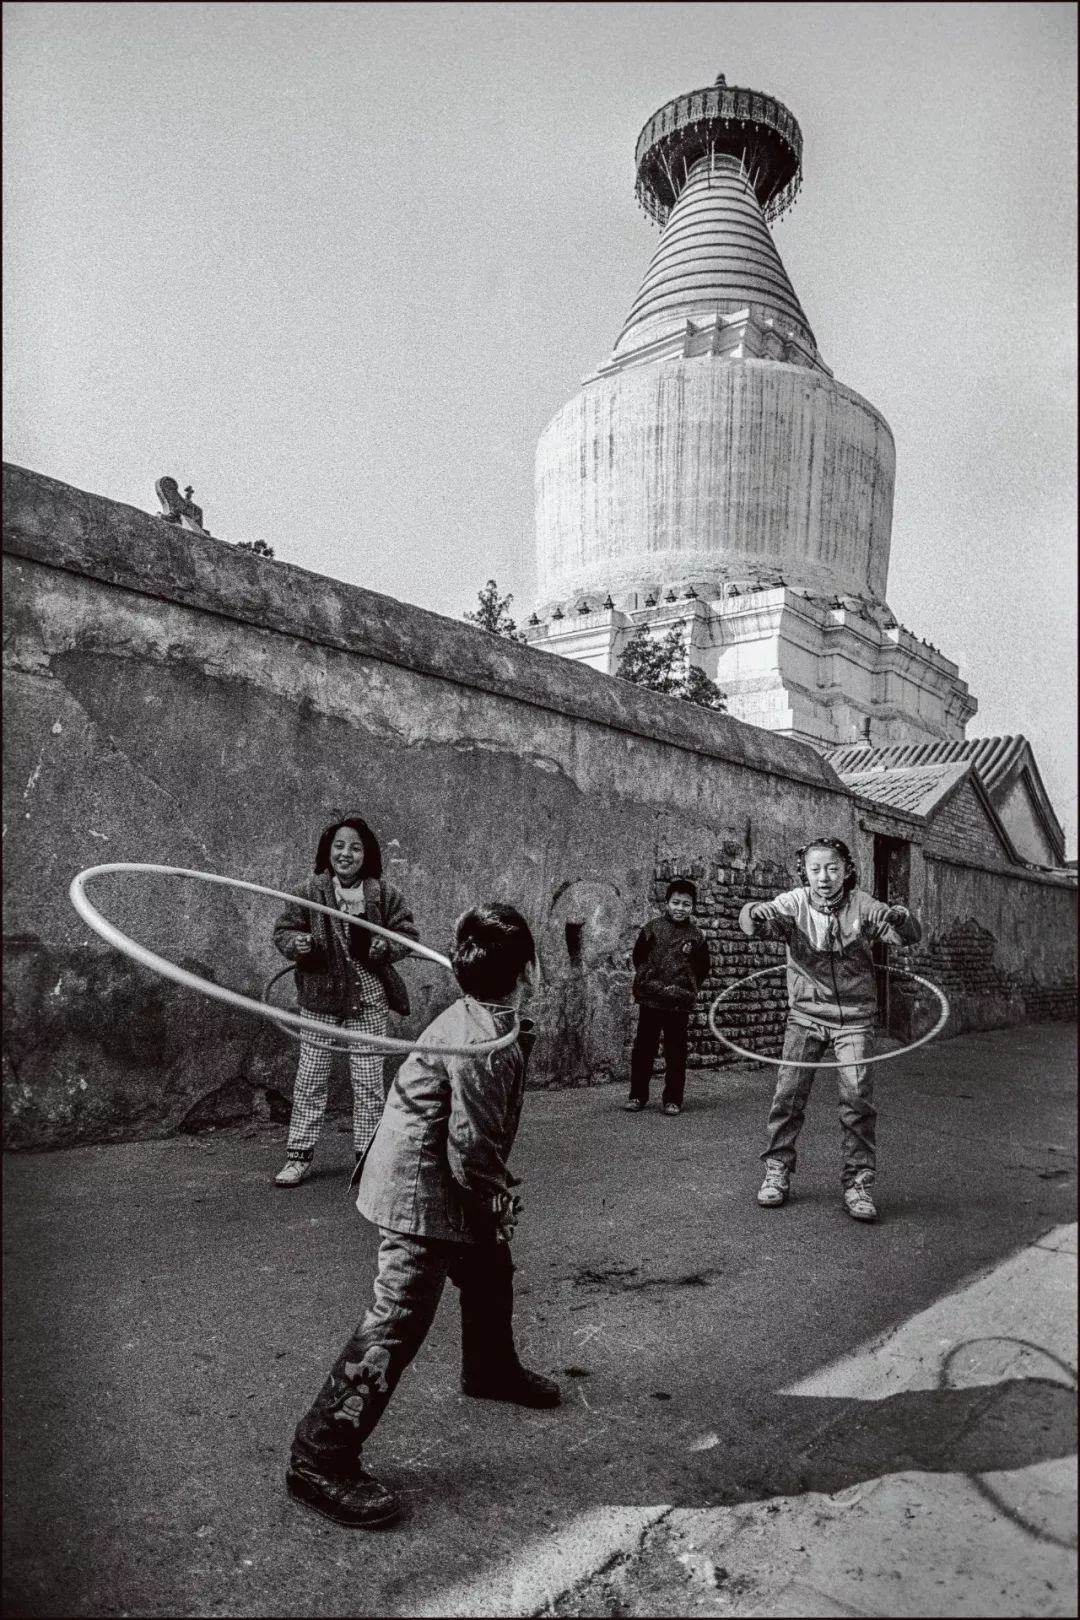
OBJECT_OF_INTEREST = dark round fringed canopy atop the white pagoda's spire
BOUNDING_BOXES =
[635,75,803,225]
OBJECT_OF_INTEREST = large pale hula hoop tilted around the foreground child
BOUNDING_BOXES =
[68,860,521,1058]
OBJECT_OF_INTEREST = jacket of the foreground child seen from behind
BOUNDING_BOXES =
[356,996,525,1243]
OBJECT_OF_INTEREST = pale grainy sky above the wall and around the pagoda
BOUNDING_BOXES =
[3,0,1077,854]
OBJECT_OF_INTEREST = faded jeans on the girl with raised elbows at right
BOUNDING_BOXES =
[761,1019,878,1187]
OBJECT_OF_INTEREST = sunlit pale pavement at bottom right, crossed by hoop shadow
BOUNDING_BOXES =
[544,1223,1077,1620]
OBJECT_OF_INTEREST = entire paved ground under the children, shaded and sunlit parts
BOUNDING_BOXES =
[3,1025,1075,1617]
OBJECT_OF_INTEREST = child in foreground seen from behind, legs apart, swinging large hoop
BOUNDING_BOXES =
[287,904,560,1529]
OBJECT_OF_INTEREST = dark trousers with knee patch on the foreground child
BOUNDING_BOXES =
[293,1228,518,1474]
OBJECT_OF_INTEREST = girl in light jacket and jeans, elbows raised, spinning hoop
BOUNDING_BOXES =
[738,838,923,1220]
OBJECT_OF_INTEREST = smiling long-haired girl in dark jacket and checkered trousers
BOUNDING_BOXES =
[274,813,419,1187]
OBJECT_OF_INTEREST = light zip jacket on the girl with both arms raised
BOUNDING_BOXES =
[738,888,923,1029]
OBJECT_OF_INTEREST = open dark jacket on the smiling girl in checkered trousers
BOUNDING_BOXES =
[274,872,419,1017]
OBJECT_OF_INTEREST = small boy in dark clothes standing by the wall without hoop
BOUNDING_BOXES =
[623,878,709,1115]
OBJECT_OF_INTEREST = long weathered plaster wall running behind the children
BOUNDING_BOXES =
[3,468,1070,1147]
